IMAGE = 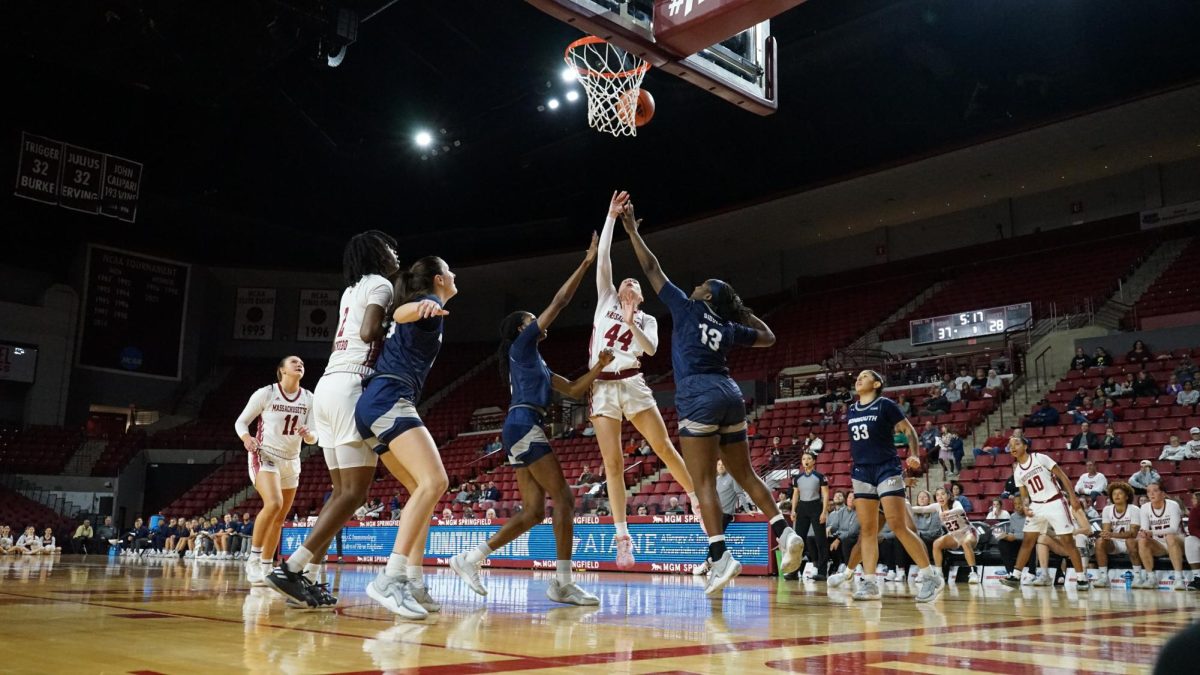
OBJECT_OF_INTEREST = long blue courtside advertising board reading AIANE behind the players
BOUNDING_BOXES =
[282,515,772,575]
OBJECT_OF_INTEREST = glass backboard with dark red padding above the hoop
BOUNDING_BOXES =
[526,0,804,115]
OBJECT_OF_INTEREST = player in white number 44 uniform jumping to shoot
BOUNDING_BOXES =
[588,192,696,568]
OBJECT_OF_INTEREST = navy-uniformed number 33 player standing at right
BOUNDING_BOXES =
[846,370,946,603]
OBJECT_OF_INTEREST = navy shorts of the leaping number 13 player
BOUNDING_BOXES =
[676,375,746,446]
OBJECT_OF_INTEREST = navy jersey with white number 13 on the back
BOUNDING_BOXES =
[659,276,758,374]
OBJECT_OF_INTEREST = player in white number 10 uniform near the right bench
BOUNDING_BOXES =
[1001,436,1088,591]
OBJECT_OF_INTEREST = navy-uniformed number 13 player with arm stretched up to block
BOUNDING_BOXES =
[622,201,804,595]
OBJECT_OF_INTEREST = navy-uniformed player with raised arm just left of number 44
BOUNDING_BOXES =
[450,234,613,605]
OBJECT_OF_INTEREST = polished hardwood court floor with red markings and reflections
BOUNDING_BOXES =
[0,556,1200,675]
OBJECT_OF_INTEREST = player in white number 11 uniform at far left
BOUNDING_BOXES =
[234,357,317,586]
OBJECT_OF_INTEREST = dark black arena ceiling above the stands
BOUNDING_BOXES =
[0,0,1200,273]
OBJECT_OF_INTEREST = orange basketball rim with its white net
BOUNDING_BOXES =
[563,35,650,137]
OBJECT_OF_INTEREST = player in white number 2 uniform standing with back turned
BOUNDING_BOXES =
[266,229,400,609]
